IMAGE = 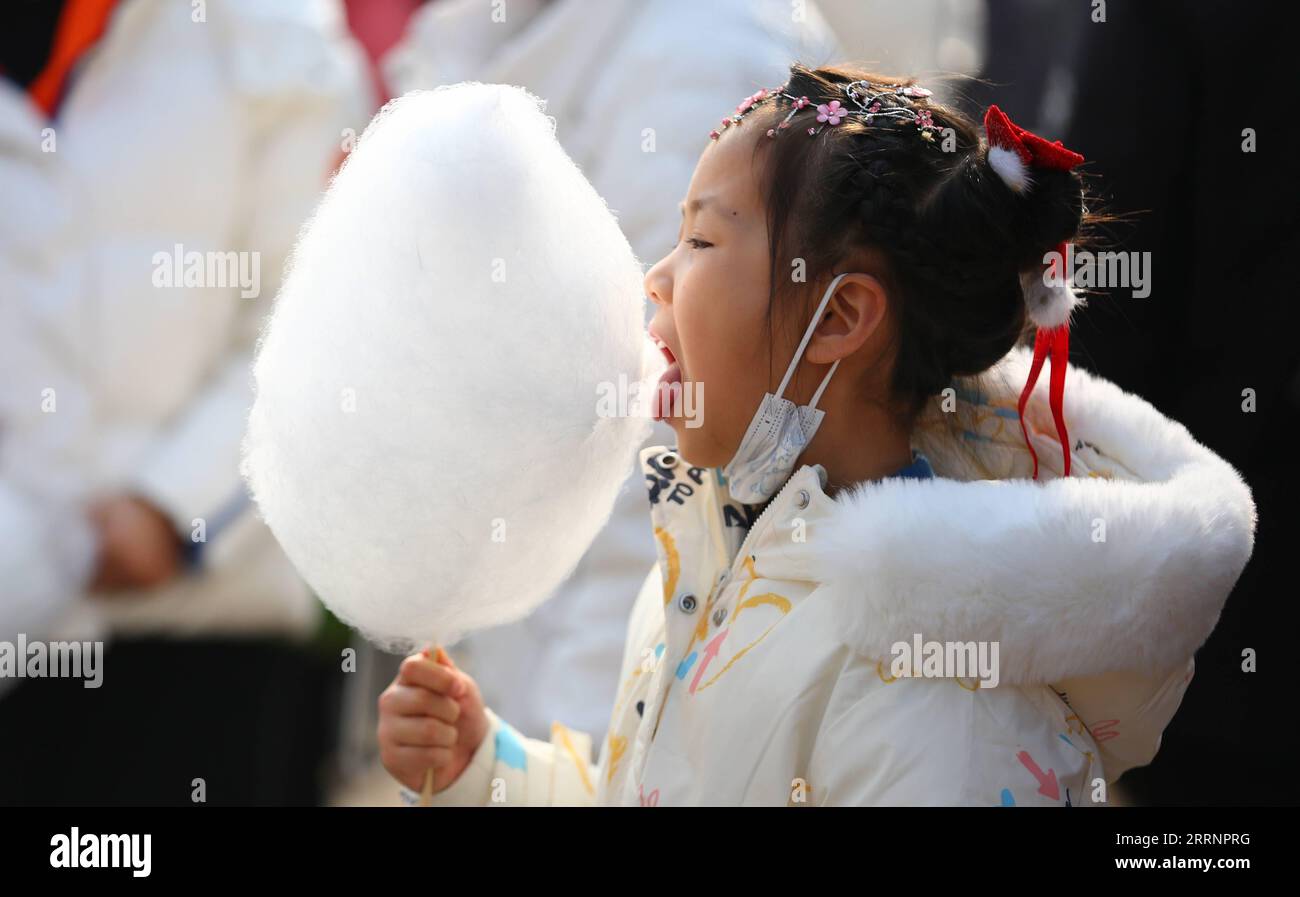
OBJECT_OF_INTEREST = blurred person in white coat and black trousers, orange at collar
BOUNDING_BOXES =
[0,0,367,803]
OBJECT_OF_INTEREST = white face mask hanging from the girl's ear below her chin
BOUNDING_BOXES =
[723,274,846,504]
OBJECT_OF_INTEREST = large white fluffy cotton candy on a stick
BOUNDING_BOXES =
[244,83,662,649]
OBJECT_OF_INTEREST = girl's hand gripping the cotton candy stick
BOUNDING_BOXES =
[378,647,488,792]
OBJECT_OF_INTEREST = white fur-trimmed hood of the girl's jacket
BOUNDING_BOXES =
[809,350,1256,684]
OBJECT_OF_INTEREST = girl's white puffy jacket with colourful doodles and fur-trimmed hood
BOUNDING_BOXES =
[410,350,1255,806]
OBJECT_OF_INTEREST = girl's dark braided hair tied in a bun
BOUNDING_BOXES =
[742,64,1087,417]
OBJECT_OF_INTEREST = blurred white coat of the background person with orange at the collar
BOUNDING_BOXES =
[0,0,368,638]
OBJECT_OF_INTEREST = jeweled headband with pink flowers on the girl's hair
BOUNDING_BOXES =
[709,81,940,146]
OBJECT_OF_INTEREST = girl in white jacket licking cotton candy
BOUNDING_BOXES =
[378,65,1255,806]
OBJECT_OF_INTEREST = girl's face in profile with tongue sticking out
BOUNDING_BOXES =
[645,127,793,467]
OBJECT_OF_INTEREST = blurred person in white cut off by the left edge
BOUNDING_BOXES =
[0,68,95,650]
